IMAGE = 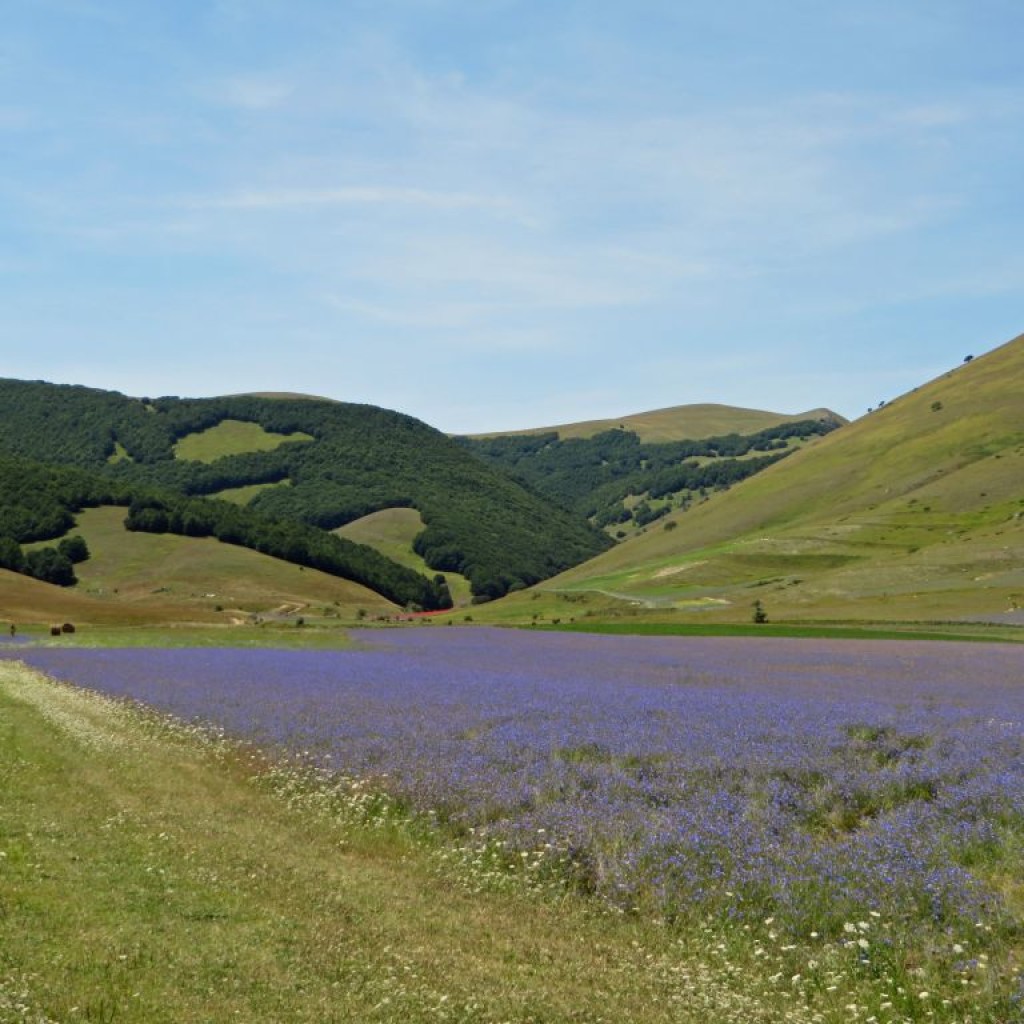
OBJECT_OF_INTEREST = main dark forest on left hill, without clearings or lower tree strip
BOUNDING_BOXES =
[0,381,609,597]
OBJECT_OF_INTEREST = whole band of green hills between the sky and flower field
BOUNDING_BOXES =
[0,336,1024,642]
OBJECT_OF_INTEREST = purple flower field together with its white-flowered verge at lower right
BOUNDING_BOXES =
[0,629,1024,1024]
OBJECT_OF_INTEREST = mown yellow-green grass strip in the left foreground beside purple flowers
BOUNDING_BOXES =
[0,663,1010,1024]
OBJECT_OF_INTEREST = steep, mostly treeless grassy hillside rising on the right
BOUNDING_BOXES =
[528,337,1024,620]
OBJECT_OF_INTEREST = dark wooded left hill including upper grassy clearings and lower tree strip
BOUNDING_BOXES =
[0,380,610,608]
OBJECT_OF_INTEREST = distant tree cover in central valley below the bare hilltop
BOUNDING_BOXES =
[459,419,839,526]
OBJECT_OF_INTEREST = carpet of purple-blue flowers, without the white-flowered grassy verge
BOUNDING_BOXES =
[0,628,1024,934]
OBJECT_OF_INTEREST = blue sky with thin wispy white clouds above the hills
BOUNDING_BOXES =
[0,0,1024,432]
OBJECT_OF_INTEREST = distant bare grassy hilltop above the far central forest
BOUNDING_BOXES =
[472,403,838,443]
